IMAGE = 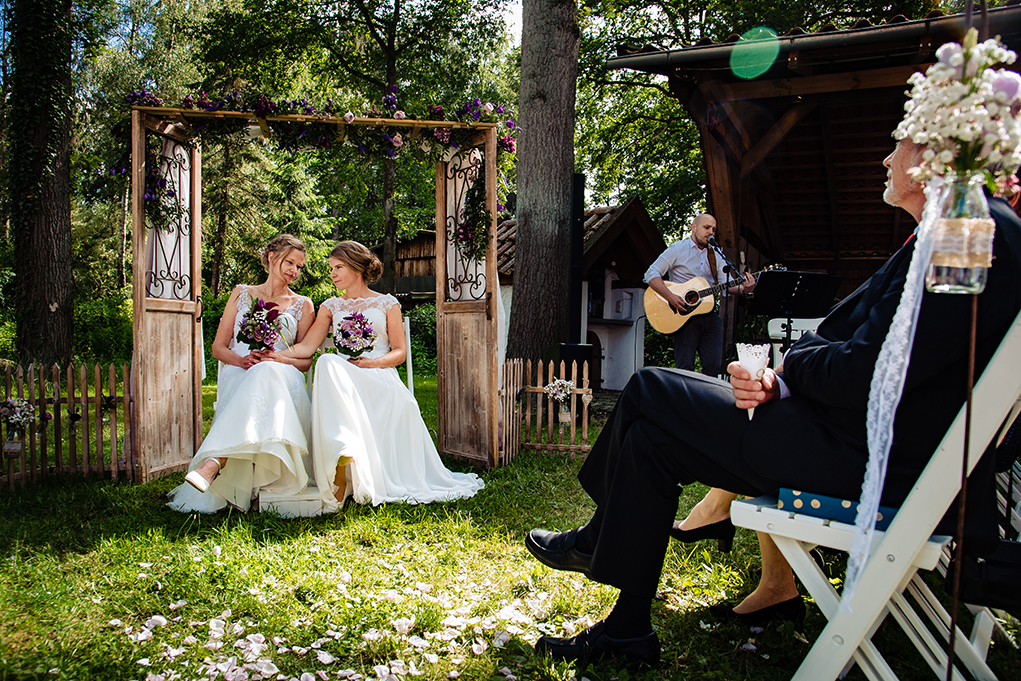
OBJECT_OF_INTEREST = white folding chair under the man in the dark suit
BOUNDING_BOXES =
[731,315,1021,681]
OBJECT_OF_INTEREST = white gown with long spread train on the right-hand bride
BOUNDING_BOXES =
[312,295,485,510]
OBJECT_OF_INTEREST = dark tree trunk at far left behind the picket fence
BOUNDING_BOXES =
[10,0,75,364]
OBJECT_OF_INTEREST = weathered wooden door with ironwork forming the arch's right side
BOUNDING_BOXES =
[436,129,499,468]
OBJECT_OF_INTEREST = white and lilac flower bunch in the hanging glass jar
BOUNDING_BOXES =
[893,28,1021,182]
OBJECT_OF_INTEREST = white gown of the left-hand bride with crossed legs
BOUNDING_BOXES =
[167,285,311,514]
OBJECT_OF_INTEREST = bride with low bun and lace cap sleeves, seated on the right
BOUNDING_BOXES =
[269,241,484,510]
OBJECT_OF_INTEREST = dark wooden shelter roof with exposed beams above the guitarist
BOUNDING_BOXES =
[609,5,1021,293]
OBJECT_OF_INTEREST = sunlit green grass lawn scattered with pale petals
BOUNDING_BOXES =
[0,377,1021,681]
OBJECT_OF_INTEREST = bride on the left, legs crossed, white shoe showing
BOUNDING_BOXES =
[167,234,314,513]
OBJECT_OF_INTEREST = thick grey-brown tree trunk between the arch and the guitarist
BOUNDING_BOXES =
[507,0,579,358]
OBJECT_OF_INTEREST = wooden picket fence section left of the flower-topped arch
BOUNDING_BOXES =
[0,363,138,489]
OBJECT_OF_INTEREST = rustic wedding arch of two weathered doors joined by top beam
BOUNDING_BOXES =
[131,106,500,481]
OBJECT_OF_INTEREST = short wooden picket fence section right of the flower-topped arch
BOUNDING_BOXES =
[500,359,592,465]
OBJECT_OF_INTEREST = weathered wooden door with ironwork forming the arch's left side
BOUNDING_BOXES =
[132,110,203,482]
